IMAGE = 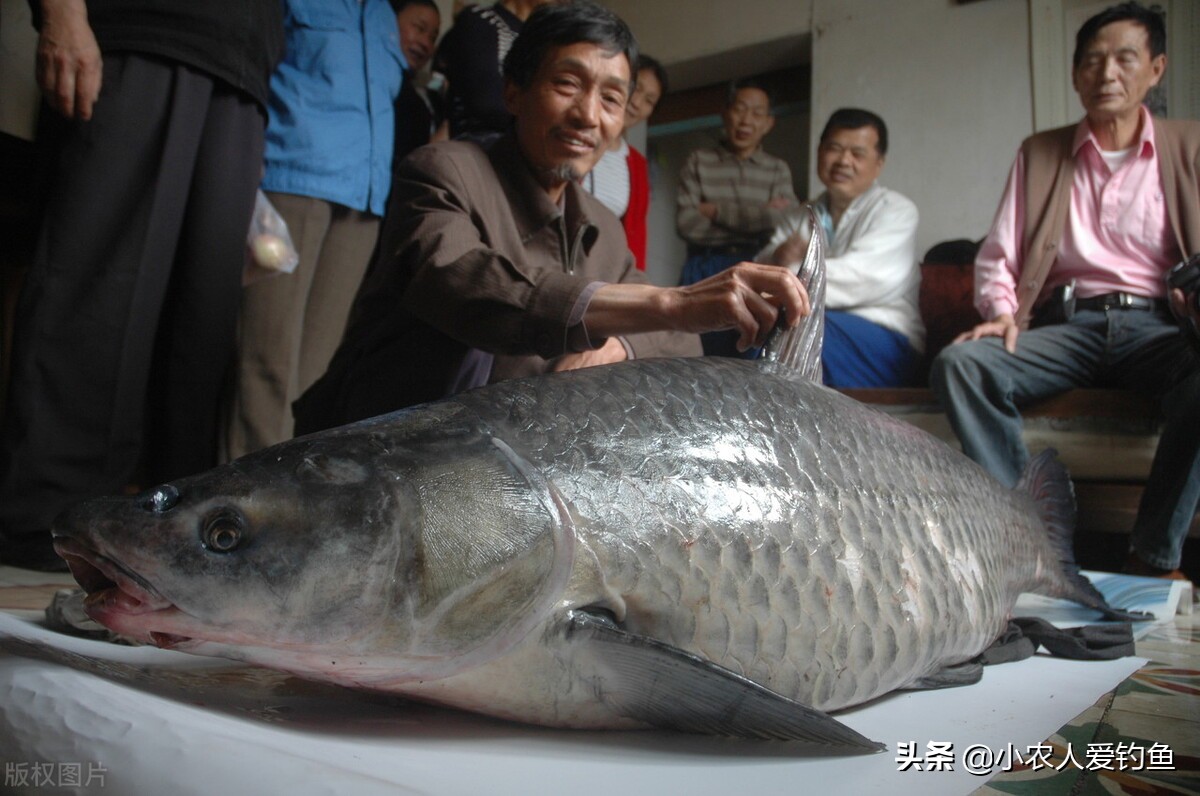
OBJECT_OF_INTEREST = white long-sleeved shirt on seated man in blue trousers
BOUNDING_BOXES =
[756,182,925,351]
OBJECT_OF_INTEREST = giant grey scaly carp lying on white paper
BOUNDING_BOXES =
[54,219,1103,749]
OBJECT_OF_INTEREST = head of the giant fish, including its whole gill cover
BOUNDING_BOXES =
[53,410,571,680]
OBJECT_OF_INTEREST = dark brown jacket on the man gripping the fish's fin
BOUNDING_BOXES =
[295,134,701,433]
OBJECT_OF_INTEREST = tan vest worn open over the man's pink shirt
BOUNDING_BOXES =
[1016,119,1200,328]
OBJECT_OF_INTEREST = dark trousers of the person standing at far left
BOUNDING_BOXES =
[0,53,265,561]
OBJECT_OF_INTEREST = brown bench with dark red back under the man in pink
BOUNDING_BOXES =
[842,263,1200,537]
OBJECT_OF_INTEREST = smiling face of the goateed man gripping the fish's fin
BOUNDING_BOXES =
[504,42,630,202]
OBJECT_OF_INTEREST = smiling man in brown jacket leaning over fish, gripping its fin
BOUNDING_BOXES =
[296,2,809,433]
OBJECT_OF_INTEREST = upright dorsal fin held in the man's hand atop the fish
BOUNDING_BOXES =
[760,204,827,383]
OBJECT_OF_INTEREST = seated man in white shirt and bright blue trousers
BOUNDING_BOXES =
[758,108,925,387]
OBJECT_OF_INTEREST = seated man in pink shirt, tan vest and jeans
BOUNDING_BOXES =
[930,4,1200,577]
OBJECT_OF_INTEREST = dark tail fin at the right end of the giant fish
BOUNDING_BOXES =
[1016,448,1140,620]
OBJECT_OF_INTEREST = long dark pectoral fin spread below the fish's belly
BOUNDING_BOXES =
[566,611,886,753]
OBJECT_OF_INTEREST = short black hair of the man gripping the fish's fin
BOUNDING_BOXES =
[504,0,637,91]
